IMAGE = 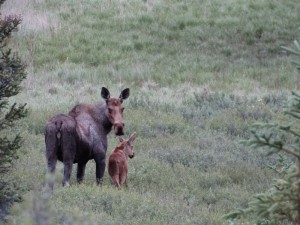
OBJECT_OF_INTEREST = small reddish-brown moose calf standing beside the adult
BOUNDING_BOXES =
[108,133,136,188]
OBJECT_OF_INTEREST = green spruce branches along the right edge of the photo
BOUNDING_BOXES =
[224,41,300,225]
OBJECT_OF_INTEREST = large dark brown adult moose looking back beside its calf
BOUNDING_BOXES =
[45,87,130,188]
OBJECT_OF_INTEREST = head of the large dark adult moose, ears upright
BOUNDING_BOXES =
[101,87,130,136]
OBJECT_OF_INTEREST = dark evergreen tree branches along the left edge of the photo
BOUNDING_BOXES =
[0,1,27,199]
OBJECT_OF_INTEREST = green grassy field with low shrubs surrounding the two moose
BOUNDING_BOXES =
[2,0,300,225]
